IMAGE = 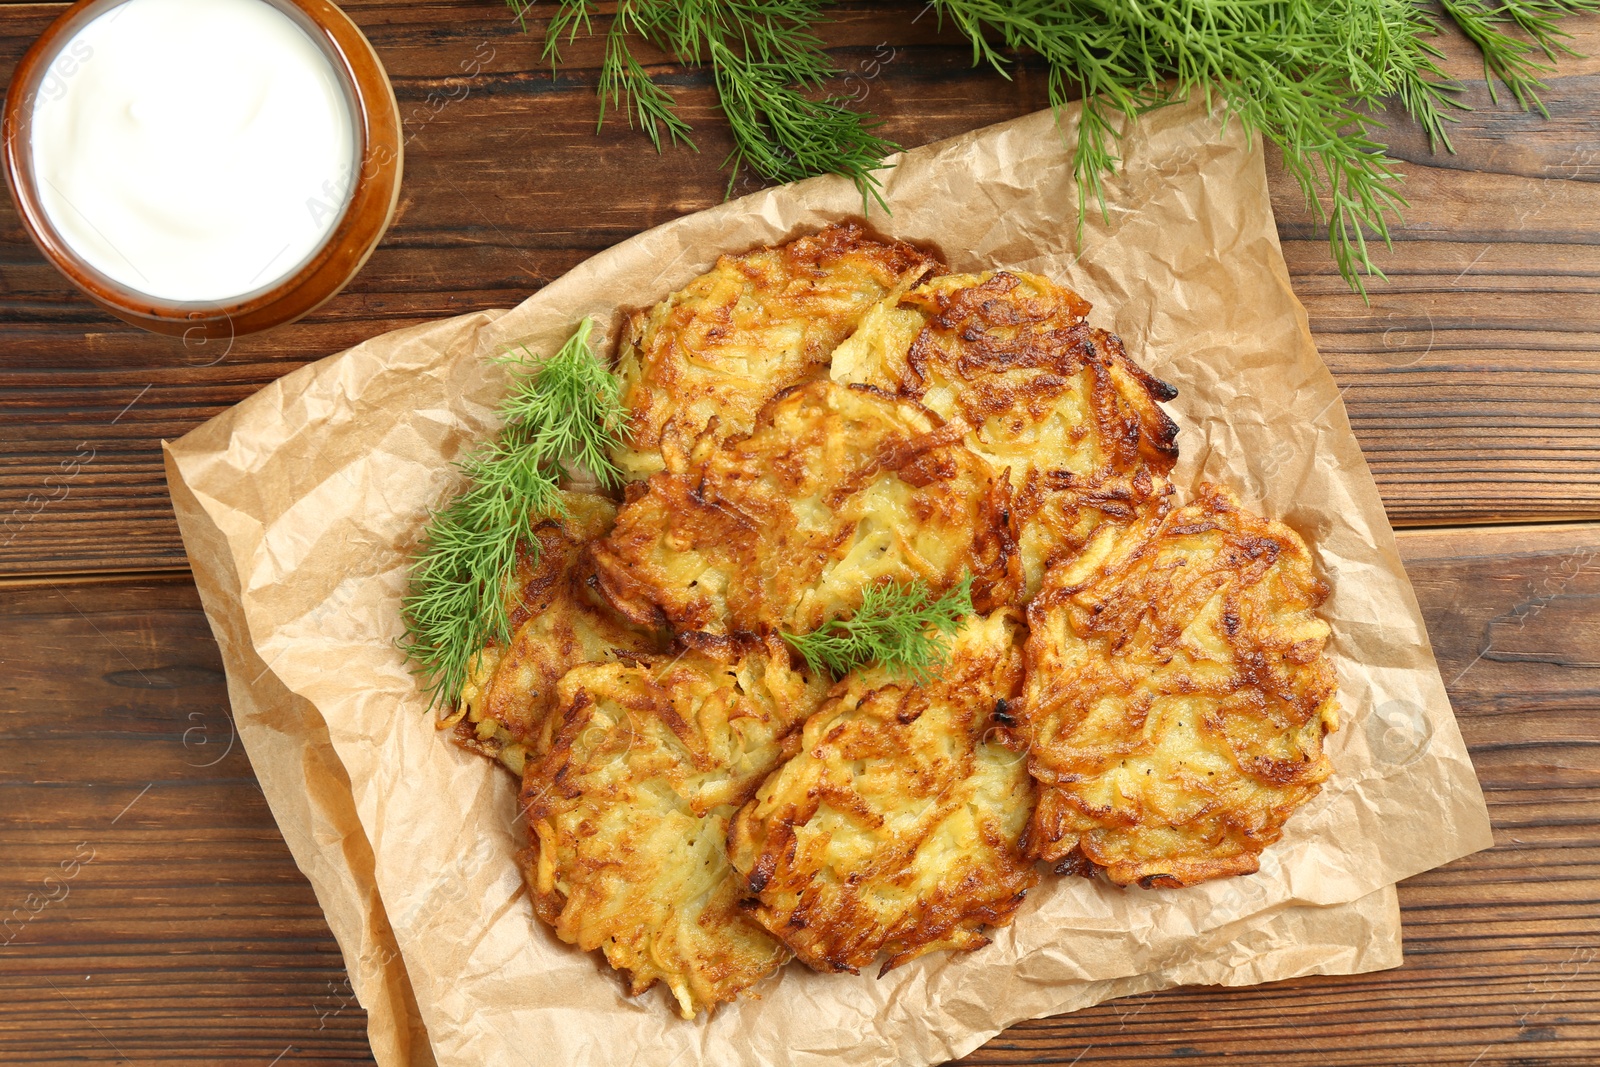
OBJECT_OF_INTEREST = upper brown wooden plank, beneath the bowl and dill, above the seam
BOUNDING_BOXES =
[0,0,1600,574]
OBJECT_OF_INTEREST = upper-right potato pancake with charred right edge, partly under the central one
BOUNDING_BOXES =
[830,270,1178,597]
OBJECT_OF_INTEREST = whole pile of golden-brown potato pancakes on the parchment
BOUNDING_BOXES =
[451,226,1336,1017]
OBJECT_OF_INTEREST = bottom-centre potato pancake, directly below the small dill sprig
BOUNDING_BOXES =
[728,608,1038,973]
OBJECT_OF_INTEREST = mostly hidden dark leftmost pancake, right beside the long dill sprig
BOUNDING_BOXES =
[451,493,661,777]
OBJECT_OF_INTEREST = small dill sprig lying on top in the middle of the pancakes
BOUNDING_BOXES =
[781,574,973,683]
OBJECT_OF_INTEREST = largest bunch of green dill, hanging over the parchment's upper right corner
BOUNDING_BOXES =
[931,0,1453,291]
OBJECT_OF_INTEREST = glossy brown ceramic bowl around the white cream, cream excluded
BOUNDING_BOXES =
[0,0,403,338]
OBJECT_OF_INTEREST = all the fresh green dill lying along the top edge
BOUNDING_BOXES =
[507,0,1600,293]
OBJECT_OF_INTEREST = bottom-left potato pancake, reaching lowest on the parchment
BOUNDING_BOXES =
[522,640,826,1019]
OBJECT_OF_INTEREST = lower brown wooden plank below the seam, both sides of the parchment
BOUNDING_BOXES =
[0,525,1600,1067]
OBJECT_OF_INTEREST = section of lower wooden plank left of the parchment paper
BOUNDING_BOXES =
[0,579,370,1064]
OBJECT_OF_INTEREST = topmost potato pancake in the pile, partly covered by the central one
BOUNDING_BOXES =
[616,224,939,478]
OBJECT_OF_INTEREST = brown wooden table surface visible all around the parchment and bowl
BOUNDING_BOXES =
[0,0,1600,1067]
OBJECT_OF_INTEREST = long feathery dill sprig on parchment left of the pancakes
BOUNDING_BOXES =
[400,318,624,704]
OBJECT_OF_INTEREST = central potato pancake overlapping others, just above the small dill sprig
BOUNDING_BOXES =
[594,379,1019,633]
